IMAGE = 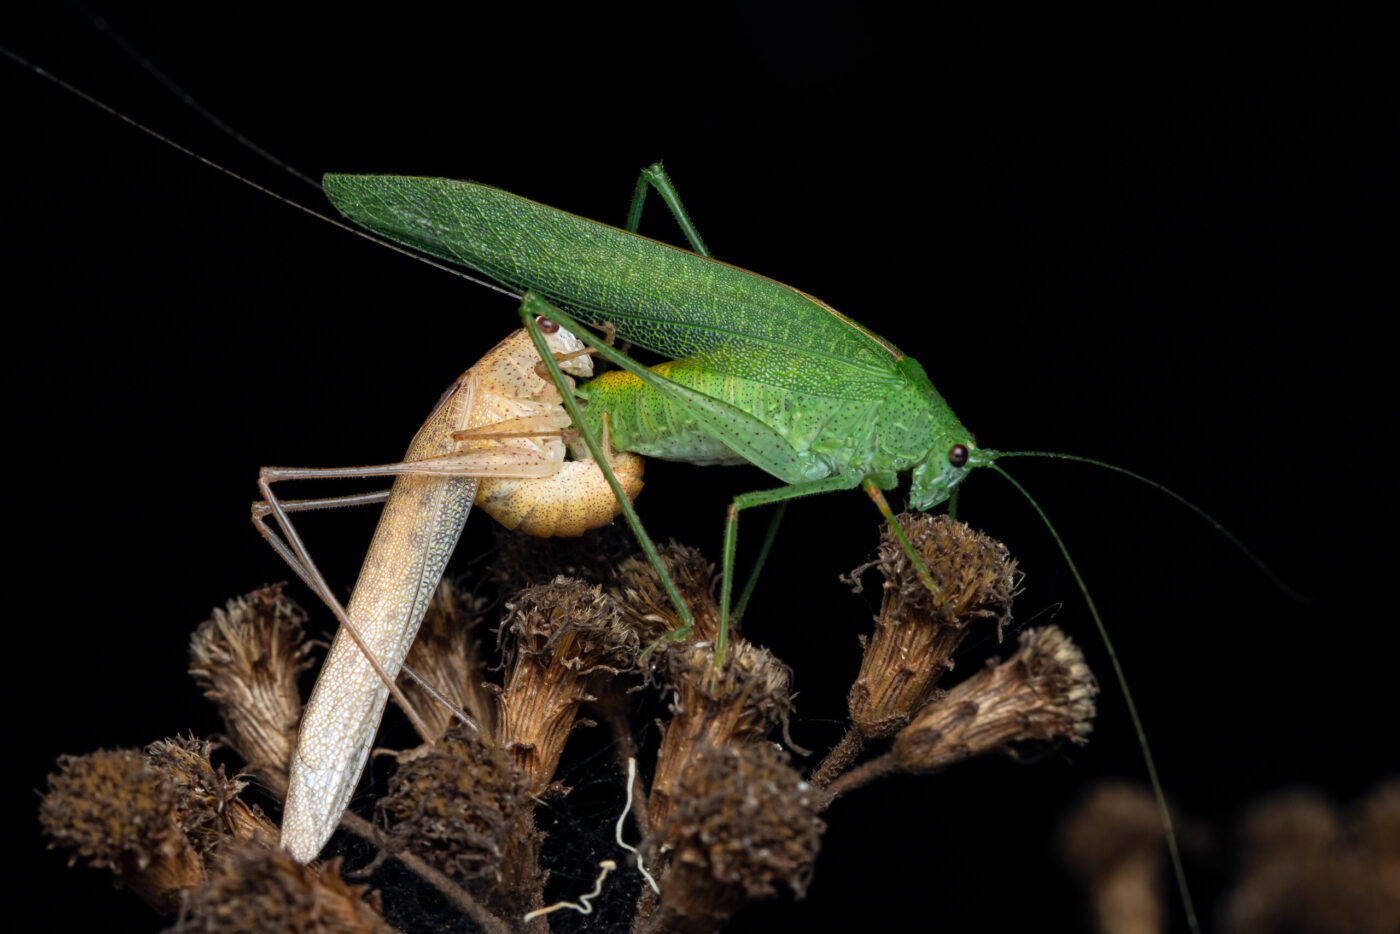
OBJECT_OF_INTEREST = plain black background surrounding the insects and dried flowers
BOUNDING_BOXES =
[0,3,1400,931]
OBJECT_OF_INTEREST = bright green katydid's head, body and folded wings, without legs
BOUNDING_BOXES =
[323,175,976,508]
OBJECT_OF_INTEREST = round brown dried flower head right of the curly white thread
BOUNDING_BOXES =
[657,744,826,934]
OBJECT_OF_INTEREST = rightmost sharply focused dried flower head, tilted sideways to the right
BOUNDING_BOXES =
[892,626,1099,772]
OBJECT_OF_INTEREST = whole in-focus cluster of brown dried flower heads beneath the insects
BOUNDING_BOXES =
[41,517,1114,934]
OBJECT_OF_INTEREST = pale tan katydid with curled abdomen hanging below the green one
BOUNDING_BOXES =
[253,322,643,863]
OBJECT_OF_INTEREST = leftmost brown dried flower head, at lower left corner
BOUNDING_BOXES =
[39,749,204,913]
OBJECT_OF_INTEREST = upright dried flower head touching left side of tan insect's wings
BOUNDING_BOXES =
[189,584,311,798]
